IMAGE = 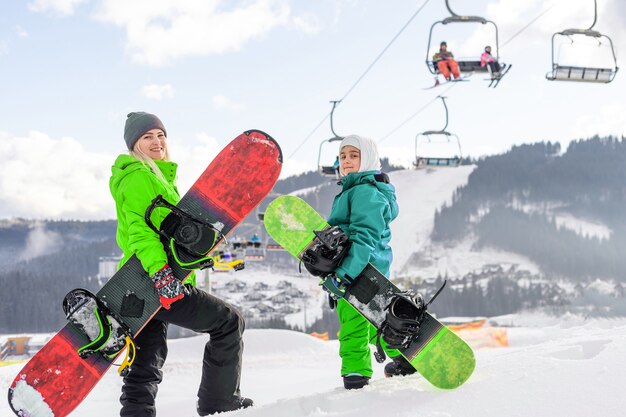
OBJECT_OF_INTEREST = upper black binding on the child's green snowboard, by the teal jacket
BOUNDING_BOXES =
[301,226,350,277]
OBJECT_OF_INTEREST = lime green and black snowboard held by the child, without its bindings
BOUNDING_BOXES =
[263,195,476,389]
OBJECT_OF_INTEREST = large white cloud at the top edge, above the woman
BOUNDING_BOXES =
[97,0,289,66]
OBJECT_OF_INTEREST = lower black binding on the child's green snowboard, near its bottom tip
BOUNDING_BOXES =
[374,281,446,363]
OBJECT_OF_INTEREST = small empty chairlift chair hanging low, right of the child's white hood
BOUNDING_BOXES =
[413,96,462,169]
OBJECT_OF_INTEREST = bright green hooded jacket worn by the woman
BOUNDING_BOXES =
[109,154,195,284]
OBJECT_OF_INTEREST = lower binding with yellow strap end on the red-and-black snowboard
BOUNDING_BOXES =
[63,288,135,375]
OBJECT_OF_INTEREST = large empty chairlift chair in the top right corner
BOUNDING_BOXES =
[546,0,619,84]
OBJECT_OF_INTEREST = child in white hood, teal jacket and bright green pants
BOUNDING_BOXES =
[328,135,398,389]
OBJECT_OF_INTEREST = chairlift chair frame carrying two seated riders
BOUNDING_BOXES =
[426,0,507,87]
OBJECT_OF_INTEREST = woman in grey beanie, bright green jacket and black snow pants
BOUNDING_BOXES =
[109,112,252,417]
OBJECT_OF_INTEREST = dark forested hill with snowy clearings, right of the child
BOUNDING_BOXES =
[432,137,626,282]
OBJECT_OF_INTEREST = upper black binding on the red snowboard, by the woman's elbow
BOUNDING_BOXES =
[144,194,224,270]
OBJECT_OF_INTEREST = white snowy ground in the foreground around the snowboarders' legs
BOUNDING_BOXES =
[0,315,626,417]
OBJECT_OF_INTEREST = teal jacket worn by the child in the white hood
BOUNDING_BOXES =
[328,171,398,278]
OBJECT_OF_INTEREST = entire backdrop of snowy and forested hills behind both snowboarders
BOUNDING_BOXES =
[0,138,626,333]
